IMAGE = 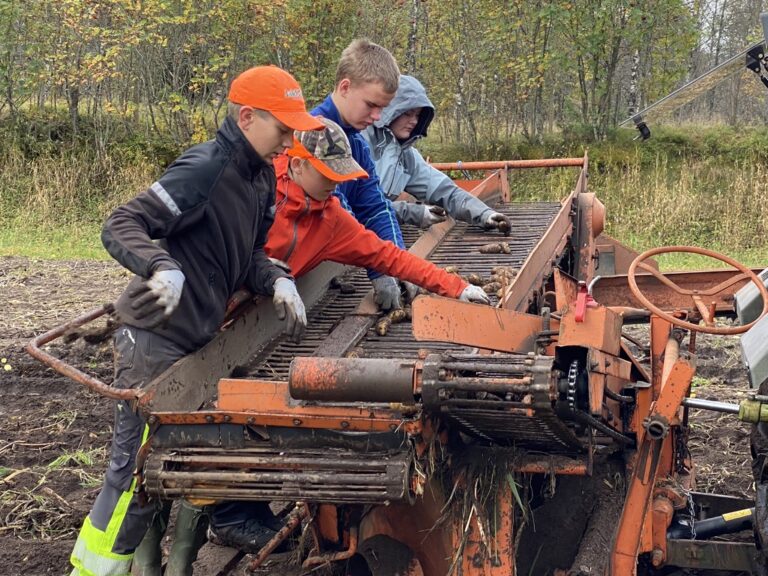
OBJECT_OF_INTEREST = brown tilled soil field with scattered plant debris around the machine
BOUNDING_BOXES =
[0,258,754,576]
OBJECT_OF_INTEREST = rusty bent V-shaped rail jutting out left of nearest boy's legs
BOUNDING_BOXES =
[26,304,139,400]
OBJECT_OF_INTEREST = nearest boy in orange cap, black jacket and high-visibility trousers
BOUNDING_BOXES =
[70,66,323,576]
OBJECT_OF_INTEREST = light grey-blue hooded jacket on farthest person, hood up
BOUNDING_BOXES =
[362,75,493,226]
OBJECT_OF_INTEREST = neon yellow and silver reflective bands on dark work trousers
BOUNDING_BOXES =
[70,426,149,576]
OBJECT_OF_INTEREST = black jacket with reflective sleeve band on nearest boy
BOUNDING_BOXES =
[101,117,287,352]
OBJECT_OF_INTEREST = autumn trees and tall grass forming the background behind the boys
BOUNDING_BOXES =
[0,0,768,265]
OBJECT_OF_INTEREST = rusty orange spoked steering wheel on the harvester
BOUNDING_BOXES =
[627,246,768,335]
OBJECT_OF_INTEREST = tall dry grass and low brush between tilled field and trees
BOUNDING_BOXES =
[0,111,768,270]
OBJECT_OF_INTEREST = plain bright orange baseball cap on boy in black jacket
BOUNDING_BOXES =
[229,66,325,130]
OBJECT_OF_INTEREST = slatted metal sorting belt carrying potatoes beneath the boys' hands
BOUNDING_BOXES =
[247,202,560,380]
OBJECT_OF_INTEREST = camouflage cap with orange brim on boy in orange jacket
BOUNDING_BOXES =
[288,117,368,182]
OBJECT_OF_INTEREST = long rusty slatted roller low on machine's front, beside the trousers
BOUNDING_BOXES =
[144,447,413,503]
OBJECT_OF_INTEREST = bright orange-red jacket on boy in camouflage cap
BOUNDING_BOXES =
[264,156,467,298]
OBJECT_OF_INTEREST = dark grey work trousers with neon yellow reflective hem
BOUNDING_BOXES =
[70,326,187,576]
